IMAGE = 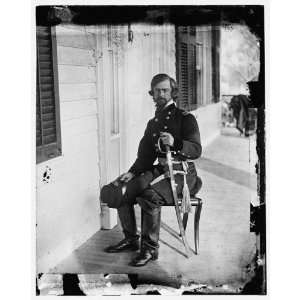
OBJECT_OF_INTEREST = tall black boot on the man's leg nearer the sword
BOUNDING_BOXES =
[130,207,161,267]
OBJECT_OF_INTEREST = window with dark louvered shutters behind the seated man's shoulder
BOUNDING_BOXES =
[176,26,220,111]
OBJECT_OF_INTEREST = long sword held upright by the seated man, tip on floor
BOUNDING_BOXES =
[165,145,193,258]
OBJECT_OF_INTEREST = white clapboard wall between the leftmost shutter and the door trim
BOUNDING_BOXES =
[36,26,100,272]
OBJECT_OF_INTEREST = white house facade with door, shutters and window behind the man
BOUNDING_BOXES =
[36,23,221,272]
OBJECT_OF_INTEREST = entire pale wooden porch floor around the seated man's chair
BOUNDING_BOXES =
[51,128,257,287]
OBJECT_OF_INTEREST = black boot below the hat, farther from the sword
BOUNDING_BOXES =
[104,204,139,253]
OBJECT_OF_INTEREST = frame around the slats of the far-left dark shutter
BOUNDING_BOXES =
[35,26,62,164]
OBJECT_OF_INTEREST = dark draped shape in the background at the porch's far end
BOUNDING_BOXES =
[229,95,250,135]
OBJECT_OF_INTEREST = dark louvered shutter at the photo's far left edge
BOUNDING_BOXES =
[36,26,61,162]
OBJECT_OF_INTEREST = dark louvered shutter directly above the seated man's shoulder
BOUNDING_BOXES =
[176,26,197,110]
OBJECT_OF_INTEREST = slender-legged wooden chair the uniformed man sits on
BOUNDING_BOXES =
[164,196,202,254]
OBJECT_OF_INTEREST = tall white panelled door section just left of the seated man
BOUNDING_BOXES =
[98,26,125,229]
